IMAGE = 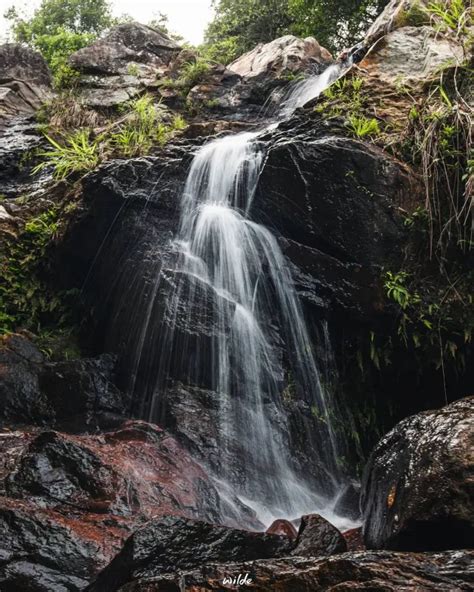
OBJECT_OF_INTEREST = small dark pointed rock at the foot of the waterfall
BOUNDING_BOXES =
[291,514,347,557]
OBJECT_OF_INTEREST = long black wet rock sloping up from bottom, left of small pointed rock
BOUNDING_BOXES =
[88,517,294,592]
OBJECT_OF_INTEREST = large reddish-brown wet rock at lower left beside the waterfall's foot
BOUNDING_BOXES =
[0,422,252,592]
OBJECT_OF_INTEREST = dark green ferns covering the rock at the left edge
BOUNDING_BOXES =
[0,209,76,334]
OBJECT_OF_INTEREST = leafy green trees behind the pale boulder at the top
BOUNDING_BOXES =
[205,0,388,63]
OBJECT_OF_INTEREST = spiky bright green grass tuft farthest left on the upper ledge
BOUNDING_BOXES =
[32,129,100,180]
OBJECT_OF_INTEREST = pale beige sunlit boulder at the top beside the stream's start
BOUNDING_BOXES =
[228,35,332,80]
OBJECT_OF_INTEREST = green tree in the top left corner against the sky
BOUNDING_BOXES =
[5,0,113,87]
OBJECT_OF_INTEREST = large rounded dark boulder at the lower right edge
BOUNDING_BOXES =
[362,397,474,551]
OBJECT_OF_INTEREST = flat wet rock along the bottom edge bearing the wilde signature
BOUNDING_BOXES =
[113,551,474,592]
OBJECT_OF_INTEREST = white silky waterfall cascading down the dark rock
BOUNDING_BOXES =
[135,61,358,523]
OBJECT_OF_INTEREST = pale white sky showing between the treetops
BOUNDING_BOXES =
[0,0,213,45]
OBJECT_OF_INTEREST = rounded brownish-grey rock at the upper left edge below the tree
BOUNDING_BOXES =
[0,43,52,123]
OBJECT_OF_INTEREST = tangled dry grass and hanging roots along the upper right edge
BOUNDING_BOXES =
[406,66,473,262]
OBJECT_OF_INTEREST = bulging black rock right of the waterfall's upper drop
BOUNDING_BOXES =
[255,128,412,265]
